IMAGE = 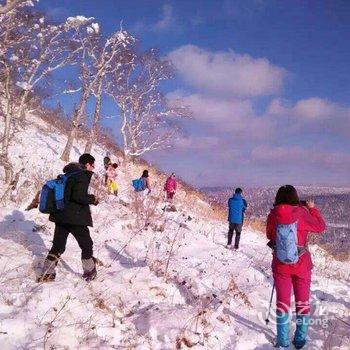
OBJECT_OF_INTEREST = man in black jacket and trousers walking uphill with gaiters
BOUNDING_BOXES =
[38,153,98,282]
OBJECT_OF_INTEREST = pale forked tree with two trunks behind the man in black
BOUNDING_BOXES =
[61,30,134,161]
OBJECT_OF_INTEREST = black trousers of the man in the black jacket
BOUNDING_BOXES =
[47,224,93,261]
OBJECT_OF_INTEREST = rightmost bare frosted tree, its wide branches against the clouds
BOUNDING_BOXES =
[111,50,190,158]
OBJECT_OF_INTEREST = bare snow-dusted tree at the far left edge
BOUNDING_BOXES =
[0,8,88,184]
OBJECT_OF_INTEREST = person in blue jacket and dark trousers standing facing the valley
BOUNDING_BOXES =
[226,188,247,249]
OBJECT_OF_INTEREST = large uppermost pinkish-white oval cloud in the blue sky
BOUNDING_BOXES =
[168,45,286,97]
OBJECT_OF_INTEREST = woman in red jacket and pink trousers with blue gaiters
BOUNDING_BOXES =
[266,185,326,349]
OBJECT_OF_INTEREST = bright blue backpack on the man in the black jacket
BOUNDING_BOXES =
[39,171,81,214]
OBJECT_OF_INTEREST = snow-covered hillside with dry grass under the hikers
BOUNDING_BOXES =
[0,117,350,350]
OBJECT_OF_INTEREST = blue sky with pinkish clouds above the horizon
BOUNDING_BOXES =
[38,0,350,186]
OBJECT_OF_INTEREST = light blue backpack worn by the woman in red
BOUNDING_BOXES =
[275,222,299,264]
